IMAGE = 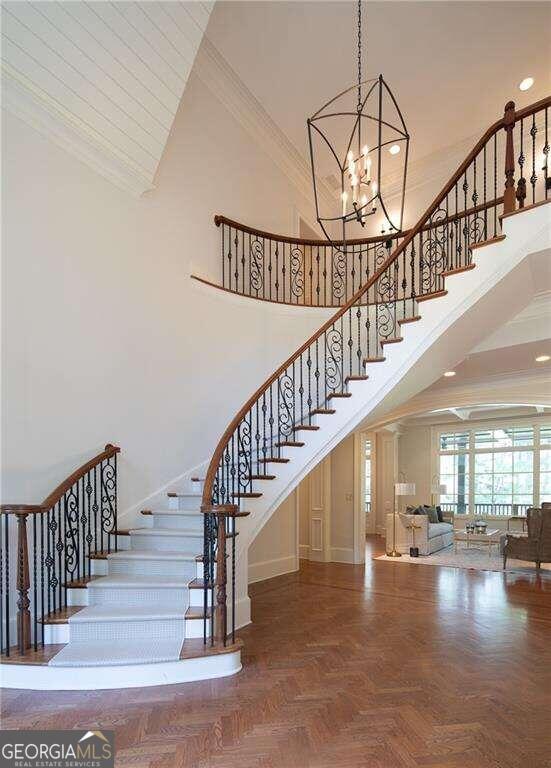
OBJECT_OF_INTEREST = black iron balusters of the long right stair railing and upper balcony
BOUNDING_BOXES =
[202,98,551,643]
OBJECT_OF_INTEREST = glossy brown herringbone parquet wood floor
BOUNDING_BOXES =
[2,537,551,768]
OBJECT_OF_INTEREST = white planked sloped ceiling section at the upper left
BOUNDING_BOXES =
[2,0,214,194]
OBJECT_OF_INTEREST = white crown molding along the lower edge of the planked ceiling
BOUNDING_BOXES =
[1,62,155,197]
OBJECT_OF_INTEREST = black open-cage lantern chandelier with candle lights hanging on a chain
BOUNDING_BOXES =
[307,0,409,250]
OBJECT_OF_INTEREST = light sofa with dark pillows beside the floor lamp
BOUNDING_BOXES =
[386,506,453,555]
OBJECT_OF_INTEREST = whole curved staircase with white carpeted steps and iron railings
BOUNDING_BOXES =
[0,93,551,688]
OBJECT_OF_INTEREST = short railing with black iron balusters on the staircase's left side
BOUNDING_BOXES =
[0,445,120,655]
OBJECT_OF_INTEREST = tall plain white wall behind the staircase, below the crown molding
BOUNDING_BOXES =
[1,74,326,509]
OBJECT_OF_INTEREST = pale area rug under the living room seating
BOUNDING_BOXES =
[374,544,551,577]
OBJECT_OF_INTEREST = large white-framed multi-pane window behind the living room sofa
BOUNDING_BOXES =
[438,424,551,516]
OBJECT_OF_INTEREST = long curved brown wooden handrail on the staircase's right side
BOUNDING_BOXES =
[202,96,551,511]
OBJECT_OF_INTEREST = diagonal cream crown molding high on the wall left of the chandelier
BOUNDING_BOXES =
[193,37,335,213]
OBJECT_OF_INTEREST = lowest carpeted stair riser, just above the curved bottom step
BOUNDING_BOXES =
[69,618,185,641]
